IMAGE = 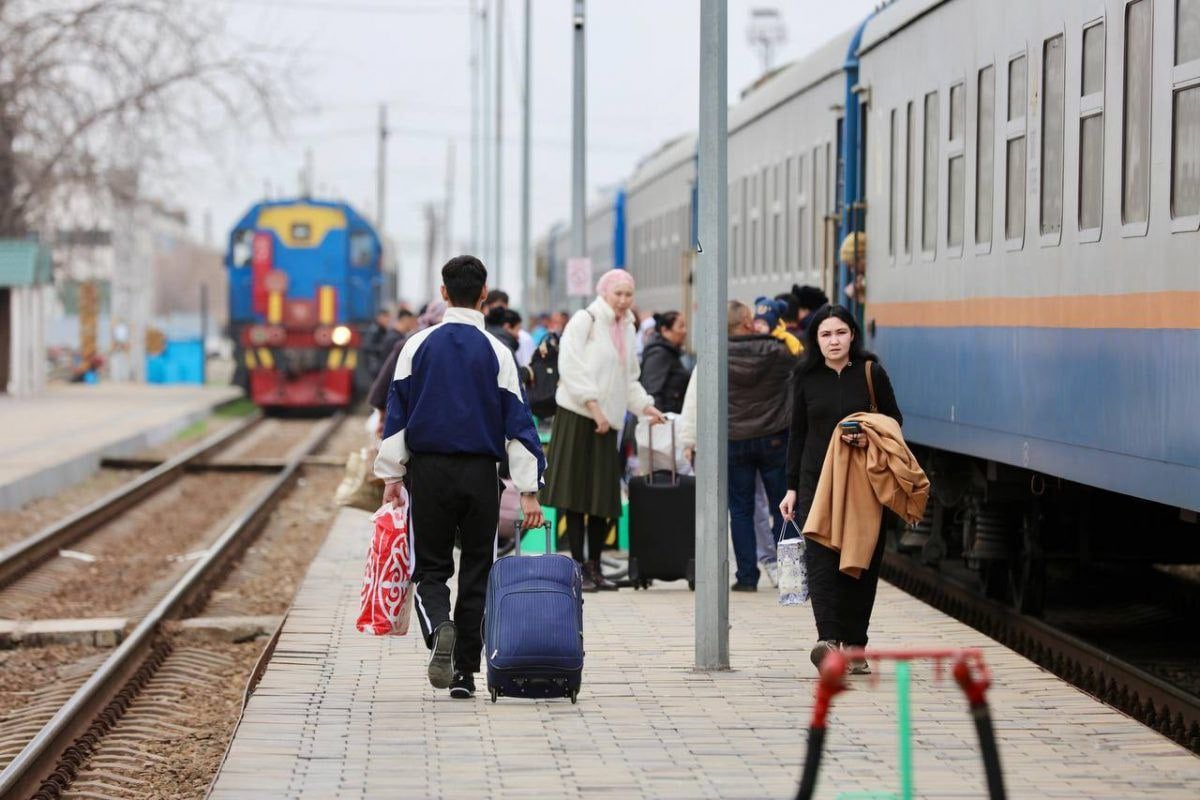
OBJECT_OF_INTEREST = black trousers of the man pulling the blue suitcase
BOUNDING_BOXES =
[408,453,502,673]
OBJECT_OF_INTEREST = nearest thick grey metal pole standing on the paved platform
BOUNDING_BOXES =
[695,0,730,670]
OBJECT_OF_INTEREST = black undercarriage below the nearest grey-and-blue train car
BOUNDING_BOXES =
[889,446,1200,615]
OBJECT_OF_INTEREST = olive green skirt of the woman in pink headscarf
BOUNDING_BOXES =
[541,408,620,519]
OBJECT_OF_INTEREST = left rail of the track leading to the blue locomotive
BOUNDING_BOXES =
[0,413,263,589]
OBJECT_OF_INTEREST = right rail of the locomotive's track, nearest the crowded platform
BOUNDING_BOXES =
[0,414,343,799]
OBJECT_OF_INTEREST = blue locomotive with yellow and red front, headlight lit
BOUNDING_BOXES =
[226,198,384,408]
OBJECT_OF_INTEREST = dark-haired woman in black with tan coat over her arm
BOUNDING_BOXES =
[779,306,904,674]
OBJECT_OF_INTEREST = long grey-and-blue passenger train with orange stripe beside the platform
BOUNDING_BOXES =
[547,0,1200,612]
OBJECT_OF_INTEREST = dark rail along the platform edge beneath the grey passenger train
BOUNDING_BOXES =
[882,552,1200,753]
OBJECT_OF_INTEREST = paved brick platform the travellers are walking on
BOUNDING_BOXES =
[211,510,1200,800]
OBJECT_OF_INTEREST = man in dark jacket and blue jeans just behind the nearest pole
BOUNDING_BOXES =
[727,300,796,591]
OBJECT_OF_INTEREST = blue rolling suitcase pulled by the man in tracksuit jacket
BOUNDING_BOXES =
[484,523,583,703]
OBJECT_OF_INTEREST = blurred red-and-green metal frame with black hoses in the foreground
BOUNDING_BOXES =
[796,648,1006,800]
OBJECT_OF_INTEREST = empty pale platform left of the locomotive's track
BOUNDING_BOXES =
[0,383,241,509]
